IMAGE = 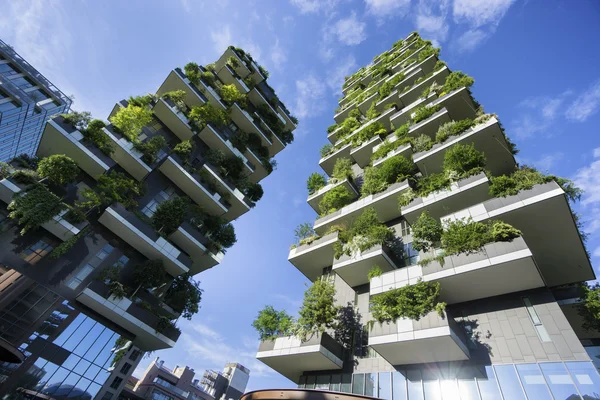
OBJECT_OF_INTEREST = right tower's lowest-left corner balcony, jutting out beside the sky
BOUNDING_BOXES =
[256,333,344,382]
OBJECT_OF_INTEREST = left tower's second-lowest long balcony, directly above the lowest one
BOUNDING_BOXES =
[98,204,192,276]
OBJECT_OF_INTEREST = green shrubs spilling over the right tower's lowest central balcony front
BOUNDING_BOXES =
[370,280,445,324]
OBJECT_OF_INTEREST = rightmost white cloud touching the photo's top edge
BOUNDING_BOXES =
[453,0,515,28]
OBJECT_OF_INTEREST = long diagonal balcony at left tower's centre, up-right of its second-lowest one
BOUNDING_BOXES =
[159,154,229,215]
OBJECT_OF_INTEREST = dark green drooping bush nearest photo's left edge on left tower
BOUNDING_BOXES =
[7,184,66,235]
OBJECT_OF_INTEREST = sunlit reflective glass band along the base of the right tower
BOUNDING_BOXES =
[298,362,600,400]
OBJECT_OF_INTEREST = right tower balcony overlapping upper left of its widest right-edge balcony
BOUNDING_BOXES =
[402,172,491,224]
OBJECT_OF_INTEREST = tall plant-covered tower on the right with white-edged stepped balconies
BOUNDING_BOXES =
[254,33,600,400]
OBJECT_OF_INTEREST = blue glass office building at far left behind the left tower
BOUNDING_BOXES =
[0,40,71,162]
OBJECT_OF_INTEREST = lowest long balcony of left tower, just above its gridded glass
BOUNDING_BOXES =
[77,287,175,351]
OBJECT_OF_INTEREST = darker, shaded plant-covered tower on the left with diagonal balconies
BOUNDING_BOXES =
[0,47,297,400]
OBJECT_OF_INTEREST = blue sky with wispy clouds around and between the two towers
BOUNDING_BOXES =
[0,0,600,389]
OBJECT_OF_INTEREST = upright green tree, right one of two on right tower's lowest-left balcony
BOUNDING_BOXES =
[294,279,339,341]
